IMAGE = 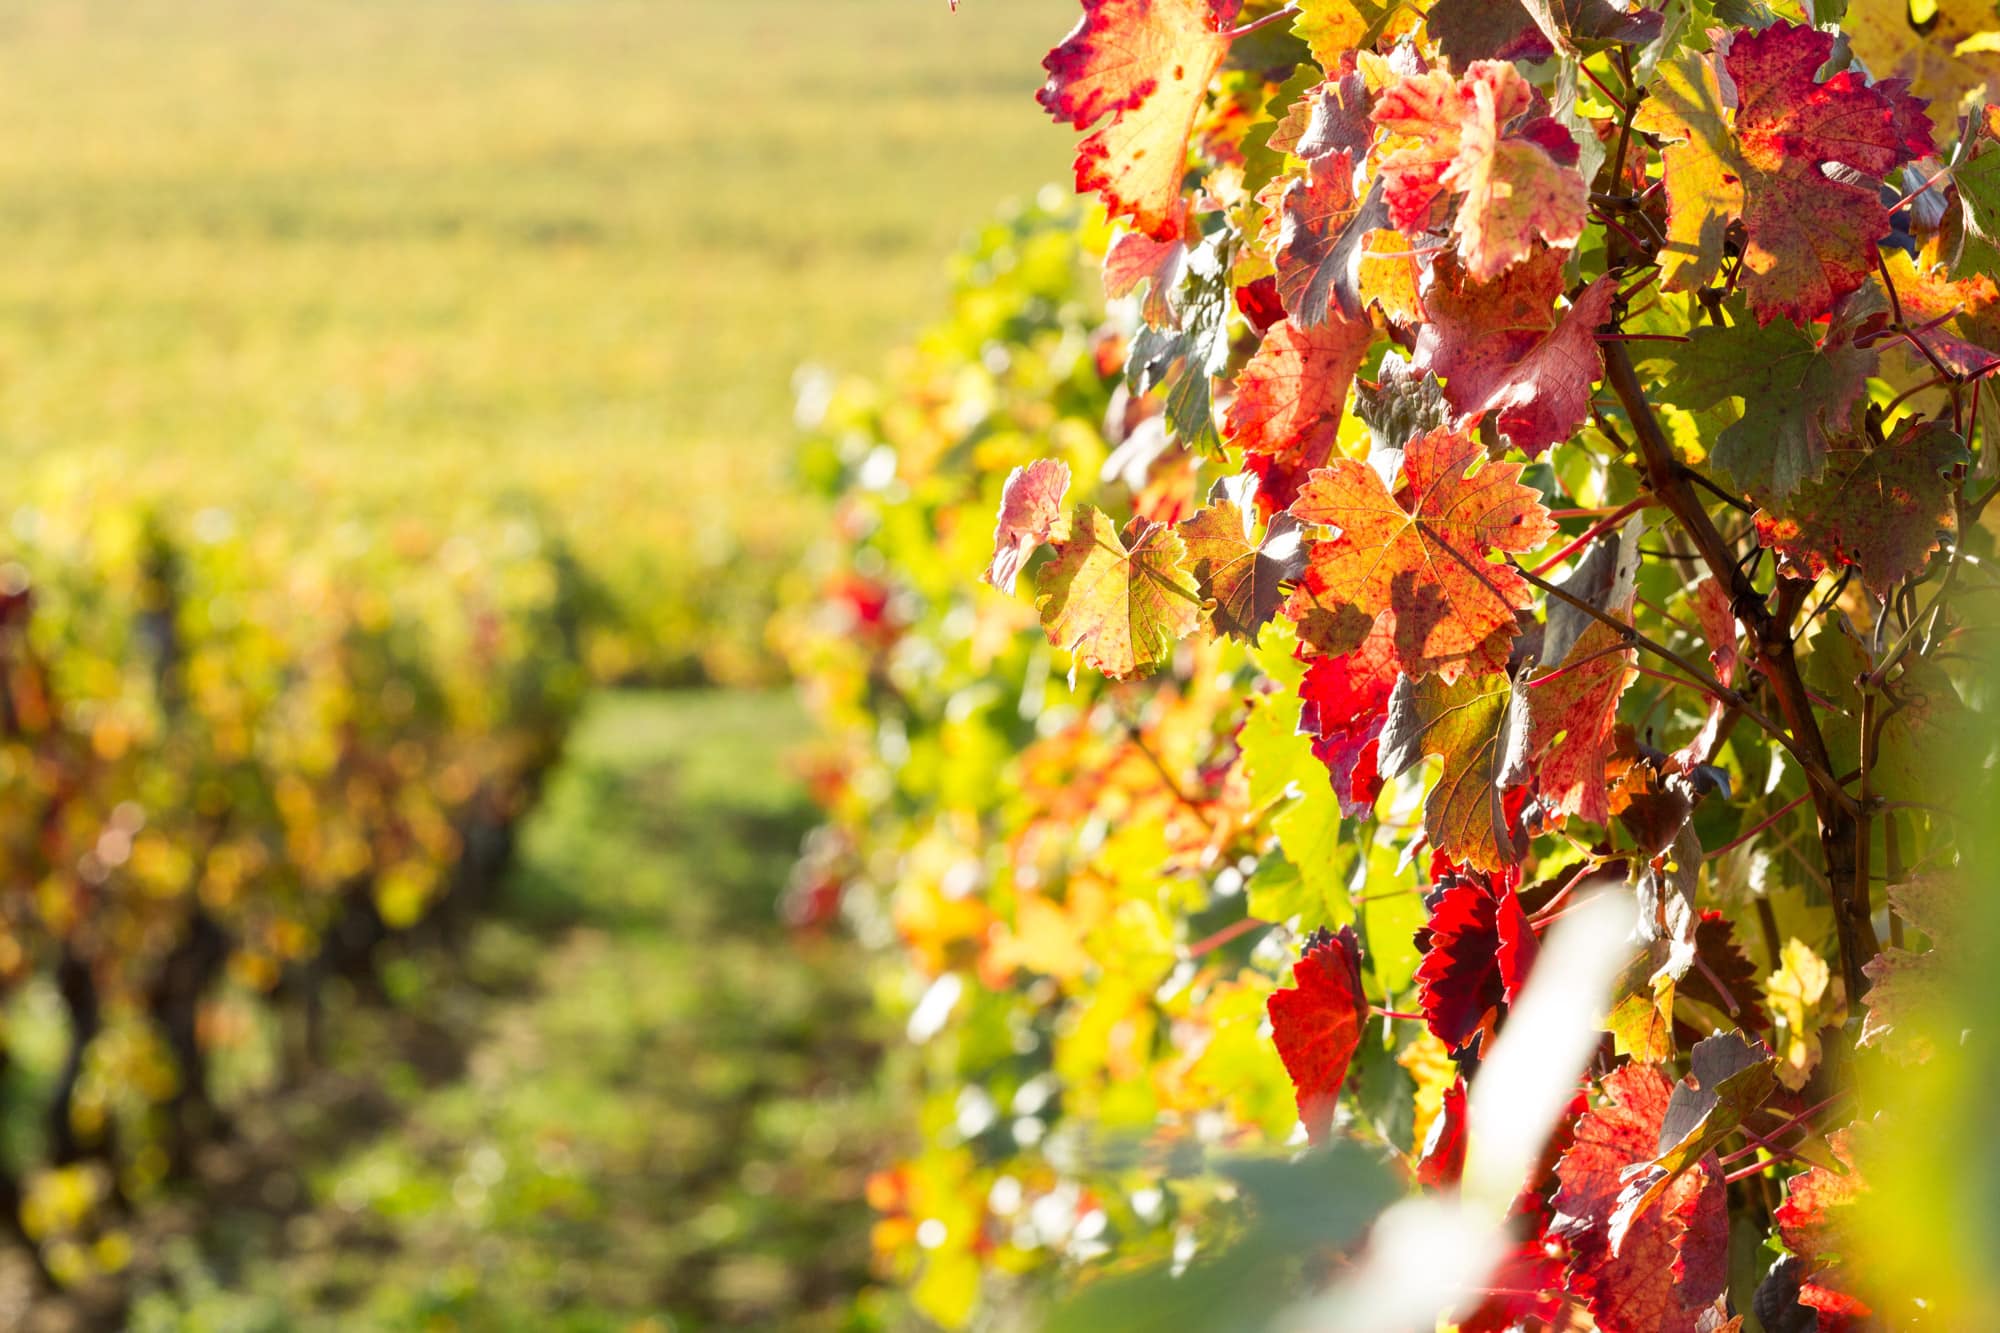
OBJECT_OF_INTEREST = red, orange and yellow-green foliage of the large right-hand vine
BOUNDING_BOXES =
[786,0,2000,1333]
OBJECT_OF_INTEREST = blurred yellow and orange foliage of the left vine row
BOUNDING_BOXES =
[0,504,592,1283]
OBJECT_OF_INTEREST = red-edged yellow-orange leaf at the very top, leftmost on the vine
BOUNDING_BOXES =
[1036,0,1240,240]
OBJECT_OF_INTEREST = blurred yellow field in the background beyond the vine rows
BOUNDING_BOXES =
[0,0,1074,669]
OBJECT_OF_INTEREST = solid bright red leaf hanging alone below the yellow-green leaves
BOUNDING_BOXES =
[1268,927,1368,1143]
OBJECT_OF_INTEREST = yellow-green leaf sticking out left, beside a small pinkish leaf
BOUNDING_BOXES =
[1038,504,1202,679]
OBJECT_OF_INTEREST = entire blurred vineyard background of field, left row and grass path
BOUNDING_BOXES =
[0,0,1060,1329]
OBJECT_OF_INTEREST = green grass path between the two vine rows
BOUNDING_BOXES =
[121,695,890,1333]
